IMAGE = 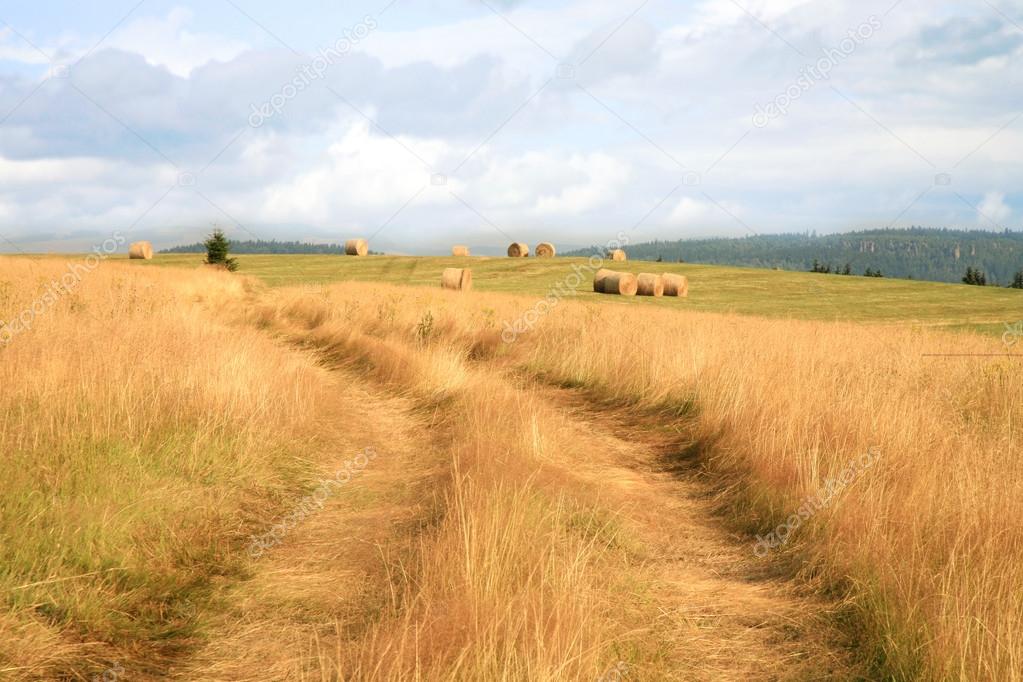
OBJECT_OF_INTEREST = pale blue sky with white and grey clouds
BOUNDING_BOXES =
[0,0,1023,254]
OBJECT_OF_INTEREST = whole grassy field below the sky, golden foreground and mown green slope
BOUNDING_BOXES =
[0,256,1023,681]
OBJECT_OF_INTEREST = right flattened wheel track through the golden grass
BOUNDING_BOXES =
[519,387,865,680]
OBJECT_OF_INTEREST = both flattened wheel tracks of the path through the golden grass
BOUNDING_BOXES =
[168,316,864,681]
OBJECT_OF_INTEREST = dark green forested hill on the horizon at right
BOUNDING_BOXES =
[565,228,1023,286]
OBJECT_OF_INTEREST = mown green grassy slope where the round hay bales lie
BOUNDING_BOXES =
[131,255,1023,334]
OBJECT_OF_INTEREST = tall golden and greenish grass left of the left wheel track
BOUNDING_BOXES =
[0,259,333,679]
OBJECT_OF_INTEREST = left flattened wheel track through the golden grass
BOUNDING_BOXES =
[166,369,450,682]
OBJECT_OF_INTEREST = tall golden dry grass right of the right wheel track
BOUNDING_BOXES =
[261,285,1023,680]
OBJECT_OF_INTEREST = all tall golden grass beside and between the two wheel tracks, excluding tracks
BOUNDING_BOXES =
[6,260,1023,680]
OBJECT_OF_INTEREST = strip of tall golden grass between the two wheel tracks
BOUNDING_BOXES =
[253,285,639,681]
